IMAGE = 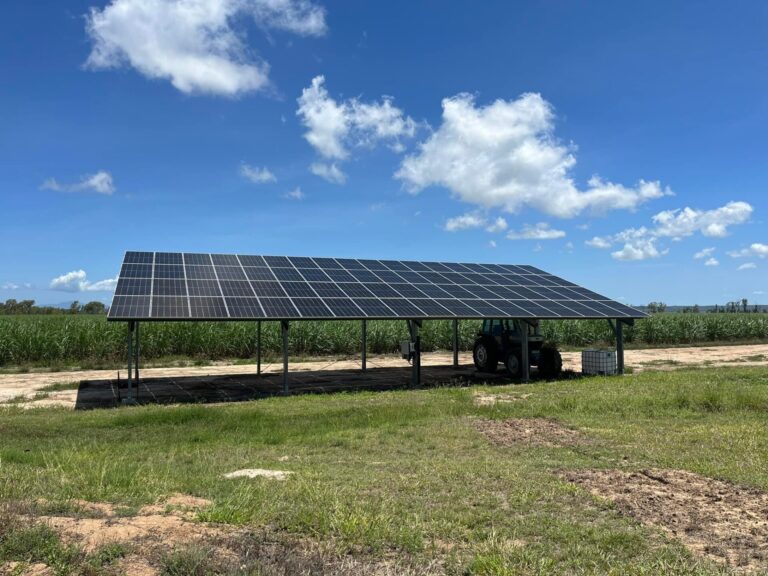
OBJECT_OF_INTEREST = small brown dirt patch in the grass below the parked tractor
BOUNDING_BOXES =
[474,418,587,446]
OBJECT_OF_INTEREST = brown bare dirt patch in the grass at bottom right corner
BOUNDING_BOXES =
[564,470,768,571]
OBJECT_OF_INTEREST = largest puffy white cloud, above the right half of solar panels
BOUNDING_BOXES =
[395,94,671,218]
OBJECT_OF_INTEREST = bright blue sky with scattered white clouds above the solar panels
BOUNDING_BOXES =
[0,0,768,304]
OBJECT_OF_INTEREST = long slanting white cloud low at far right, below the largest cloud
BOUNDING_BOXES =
[587,202,752,260]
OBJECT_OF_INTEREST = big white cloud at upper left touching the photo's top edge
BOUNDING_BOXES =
[85,0,326,96]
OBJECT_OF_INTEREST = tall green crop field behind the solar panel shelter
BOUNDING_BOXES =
[0,314,768,367]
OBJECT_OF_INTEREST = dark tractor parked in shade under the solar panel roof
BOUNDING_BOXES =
[473,318,563,379]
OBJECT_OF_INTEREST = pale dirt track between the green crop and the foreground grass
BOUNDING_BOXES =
[0,344,768,407]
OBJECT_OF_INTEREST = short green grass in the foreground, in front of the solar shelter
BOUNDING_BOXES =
[0,368,768,575]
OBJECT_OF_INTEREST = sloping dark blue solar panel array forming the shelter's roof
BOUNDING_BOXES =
[109,252,645,320]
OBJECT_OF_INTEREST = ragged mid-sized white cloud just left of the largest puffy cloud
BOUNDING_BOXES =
[296,76,417,179]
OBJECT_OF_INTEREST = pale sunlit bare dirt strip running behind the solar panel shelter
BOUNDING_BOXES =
[0,344,768,408]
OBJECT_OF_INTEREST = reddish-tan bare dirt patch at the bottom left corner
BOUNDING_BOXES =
[0,494,443,576]
